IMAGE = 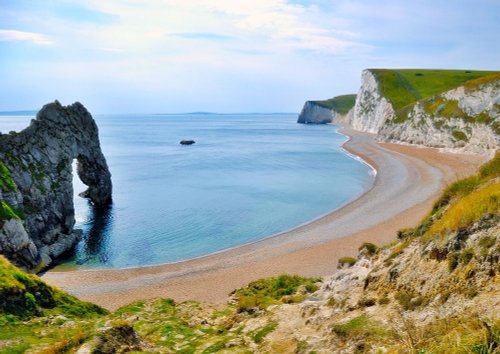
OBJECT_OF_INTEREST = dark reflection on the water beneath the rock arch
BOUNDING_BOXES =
[75,202,114,264]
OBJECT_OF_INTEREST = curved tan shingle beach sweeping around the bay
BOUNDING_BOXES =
[43,129,485,310]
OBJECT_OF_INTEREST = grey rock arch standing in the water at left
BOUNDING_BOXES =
[0,101,112,270]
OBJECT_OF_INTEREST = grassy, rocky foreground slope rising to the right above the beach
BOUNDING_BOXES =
[0,154,500,353]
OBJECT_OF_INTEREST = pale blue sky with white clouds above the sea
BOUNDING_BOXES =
[0,0,500,113]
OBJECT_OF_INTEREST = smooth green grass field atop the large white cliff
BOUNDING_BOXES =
[370,69,499,111]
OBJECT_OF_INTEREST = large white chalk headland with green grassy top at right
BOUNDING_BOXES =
[350,69,500,155]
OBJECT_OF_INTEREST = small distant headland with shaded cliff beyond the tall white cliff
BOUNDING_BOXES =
[297,95,356,124]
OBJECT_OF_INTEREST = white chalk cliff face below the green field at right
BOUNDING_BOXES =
[350,70,500,155]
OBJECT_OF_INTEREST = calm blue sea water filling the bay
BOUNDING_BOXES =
[0,114,373,268]
